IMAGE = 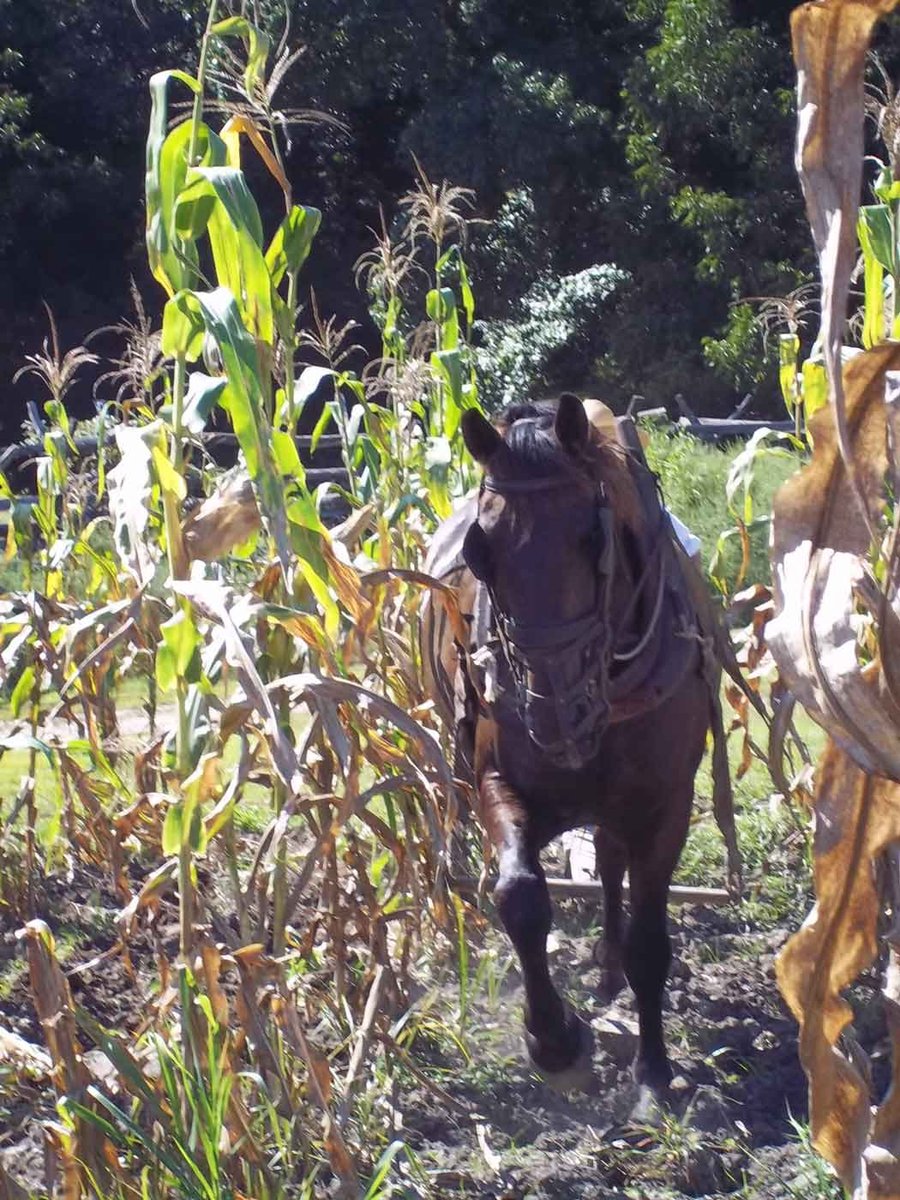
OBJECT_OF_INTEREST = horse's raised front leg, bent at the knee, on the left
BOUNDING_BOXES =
[480,774,593,1087]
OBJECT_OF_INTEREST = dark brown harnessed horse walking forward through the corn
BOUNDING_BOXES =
[422,395,709,1096]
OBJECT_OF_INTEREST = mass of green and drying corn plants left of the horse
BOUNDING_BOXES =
[0,0,489,1200]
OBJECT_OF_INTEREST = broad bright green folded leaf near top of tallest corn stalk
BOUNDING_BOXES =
[175,167,275,344]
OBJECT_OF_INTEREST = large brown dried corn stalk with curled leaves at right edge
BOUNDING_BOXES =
[767,0,900,1200]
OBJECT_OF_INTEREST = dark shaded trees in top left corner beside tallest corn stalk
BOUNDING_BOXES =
[0,0,200,437]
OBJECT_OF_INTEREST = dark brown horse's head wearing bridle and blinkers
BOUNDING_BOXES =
[462,394,612,769]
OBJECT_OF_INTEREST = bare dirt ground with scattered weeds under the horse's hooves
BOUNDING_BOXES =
[402,904,840,1200]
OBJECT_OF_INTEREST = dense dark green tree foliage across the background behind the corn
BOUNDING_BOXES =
[0,0,825,428]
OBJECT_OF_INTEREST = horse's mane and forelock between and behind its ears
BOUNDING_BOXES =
[497,401,643,533]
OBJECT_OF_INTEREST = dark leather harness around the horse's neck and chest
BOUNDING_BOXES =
[455,422,700,769]
